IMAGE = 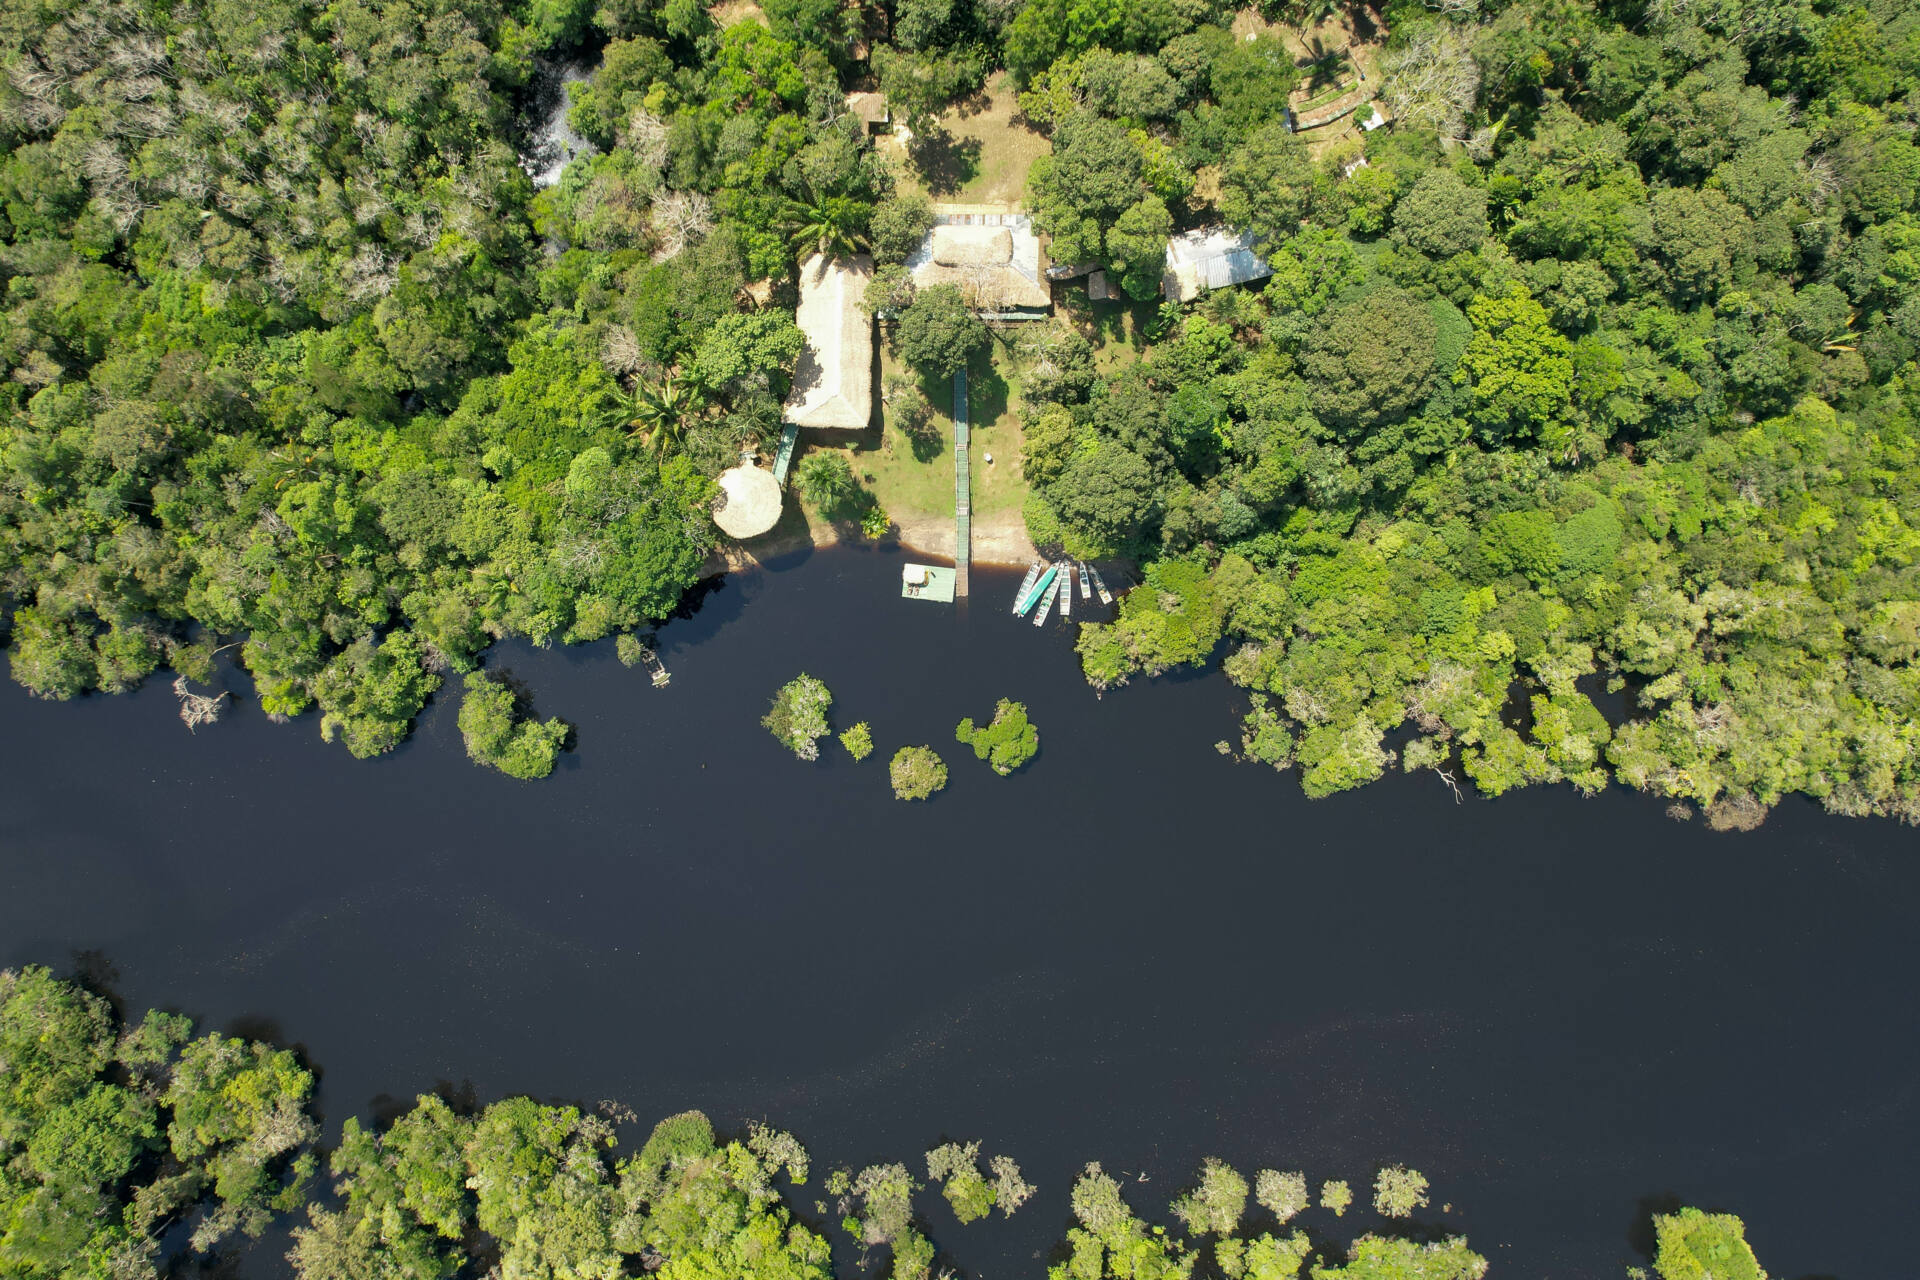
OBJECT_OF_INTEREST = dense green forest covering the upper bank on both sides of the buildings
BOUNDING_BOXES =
[0,0,1920,825]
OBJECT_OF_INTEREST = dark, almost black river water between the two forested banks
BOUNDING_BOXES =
[0,551,1920,1280]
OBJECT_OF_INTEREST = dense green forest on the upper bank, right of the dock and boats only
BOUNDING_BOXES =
[1008,0,1920,825]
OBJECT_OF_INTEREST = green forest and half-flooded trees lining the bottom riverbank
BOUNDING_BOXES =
[0,969,1764,1280]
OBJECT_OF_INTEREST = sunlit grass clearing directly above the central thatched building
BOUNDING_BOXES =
[879,71,1052,206]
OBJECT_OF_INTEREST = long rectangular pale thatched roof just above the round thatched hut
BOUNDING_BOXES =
[787,253,874,432]
